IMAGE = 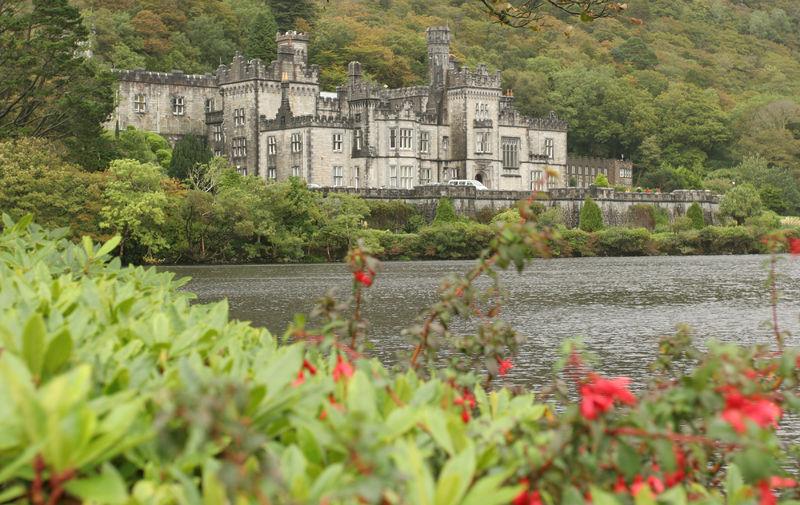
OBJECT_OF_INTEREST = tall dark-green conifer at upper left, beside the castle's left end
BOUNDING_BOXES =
[0,0,115,167]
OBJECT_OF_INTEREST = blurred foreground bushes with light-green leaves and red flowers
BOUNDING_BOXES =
[0,212,800,505]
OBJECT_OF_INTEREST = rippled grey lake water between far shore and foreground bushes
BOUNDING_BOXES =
[169,256,800,386]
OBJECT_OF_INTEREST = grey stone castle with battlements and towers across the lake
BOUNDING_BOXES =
[108,27,630,190]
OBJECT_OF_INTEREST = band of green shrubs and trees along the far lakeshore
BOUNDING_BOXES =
[0,137,800,265]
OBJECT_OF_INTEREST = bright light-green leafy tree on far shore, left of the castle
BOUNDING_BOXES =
[100,160,169,258]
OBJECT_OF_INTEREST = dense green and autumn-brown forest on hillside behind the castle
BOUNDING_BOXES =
[64,0,800,214]
